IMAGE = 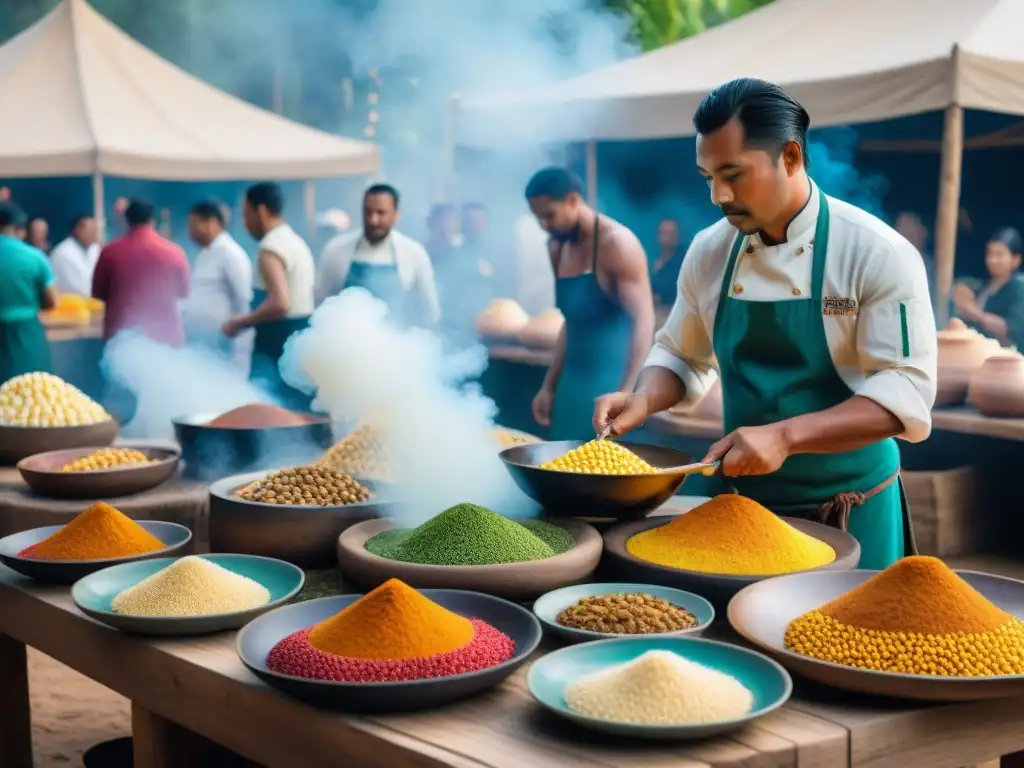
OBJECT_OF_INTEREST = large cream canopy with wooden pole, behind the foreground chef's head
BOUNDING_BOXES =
[458,0,1024,321]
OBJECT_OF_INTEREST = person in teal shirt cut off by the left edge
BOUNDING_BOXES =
[0,203,57,384]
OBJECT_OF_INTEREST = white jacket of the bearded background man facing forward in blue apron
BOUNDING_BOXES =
[316,229,441,324]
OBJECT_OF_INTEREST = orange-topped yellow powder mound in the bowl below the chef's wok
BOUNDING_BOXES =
[626,494,836,575]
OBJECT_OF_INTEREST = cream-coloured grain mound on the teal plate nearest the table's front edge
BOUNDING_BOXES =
[565,650,754,725]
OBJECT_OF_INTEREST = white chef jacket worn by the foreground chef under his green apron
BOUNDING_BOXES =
[645,183,938,442]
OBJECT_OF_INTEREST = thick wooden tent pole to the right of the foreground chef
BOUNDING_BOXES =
[933,103,964,328]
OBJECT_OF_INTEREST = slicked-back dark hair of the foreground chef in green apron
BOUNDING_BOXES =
[693,78,811,168]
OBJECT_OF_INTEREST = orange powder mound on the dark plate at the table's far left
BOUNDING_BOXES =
[17,502,167,560]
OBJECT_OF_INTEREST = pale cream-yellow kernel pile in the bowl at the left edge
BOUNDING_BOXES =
[0,372,111,427]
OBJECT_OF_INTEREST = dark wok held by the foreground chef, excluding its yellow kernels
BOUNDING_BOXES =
[499,440,691,520]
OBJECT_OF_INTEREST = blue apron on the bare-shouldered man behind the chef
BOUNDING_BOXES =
[548,218,633,440]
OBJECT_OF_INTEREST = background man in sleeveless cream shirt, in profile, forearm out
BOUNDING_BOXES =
[223,181,316,411]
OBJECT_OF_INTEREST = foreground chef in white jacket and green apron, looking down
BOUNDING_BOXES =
[594,79,937,568]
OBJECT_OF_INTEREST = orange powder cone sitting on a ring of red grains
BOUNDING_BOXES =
[309,579,475,659]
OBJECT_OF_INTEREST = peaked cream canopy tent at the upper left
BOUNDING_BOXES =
[0,0,380,233]
